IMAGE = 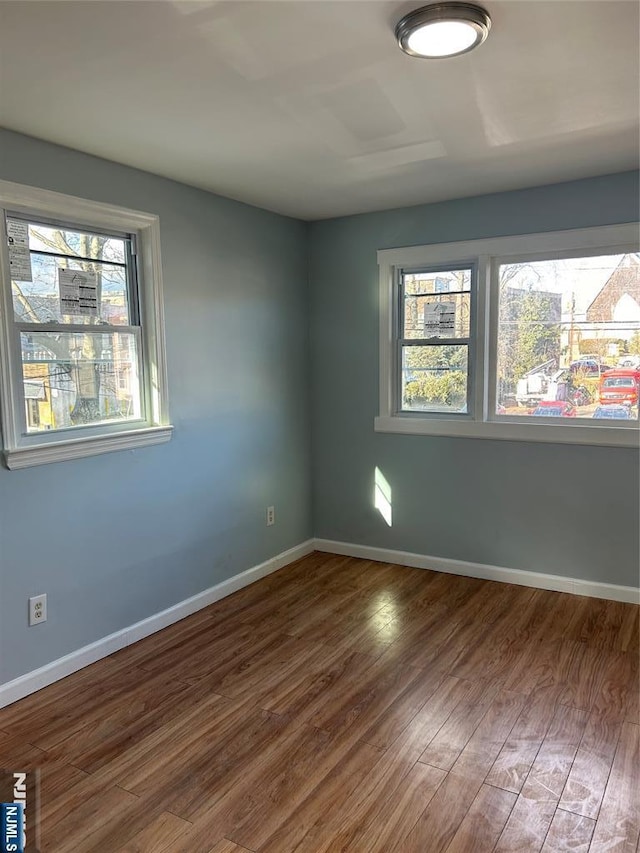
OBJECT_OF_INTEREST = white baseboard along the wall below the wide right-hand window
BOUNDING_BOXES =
[314,539,640,604]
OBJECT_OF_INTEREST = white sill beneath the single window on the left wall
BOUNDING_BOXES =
[4,425,173,470]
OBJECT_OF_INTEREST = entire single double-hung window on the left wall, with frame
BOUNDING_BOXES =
[0,182,171,468]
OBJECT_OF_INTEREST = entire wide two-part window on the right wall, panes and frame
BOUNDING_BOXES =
[376,224,640,446]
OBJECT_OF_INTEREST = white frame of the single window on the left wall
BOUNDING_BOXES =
[0,181,173,469]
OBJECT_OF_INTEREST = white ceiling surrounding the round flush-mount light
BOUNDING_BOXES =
[0,0,640,219]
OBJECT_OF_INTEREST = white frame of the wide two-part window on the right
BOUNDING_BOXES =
[374,222,640,448]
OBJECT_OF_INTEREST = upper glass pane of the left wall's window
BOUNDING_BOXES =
[12,252,131,326]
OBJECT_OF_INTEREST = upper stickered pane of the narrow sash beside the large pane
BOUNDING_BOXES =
[404,293,471,340]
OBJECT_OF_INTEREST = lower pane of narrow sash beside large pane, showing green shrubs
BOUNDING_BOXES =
[401,345,469,413]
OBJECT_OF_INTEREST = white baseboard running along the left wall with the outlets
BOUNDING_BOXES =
[0,539,314,708]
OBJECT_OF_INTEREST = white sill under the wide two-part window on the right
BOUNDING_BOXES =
[374,416,640,449]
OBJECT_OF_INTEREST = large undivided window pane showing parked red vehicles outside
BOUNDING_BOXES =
[496,254,640,420]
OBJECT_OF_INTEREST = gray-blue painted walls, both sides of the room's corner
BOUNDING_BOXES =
[0,131,639,683]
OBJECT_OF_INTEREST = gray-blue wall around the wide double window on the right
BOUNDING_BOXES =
[310,173,639,586]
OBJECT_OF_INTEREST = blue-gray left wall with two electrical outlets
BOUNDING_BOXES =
[0,131,312,683]
